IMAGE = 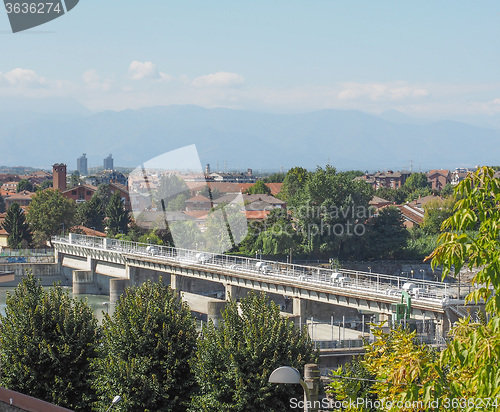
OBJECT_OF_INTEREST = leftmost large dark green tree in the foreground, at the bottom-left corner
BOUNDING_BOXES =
[0,274,99,411]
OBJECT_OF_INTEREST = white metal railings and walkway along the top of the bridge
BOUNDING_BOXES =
[54,233,470,304]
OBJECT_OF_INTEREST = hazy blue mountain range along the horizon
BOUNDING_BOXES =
[0,104,500,170]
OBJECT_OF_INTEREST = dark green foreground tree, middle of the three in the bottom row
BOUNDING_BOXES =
[95,279,196,412]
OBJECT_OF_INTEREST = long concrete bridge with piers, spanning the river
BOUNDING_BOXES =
[52,234,470,335]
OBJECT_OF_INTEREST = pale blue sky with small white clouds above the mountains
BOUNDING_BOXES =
[0,0,500,117]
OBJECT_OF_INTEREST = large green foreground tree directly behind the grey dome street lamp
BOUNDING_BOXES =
[192,292,317,412]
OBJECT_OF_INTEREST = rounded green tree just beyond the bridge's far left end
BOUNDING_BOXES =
[26,189,76,244]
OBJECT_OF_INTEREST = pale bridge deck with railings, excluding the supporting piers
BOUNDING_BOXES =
[53,234,470,312]
